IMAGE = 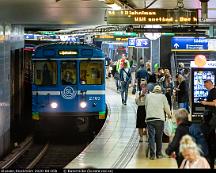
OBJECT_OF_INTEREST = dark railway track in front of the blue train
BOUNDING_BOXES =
[0,135,89,169]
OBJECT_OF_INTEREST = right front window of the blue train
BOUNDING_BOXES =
[80,61,104,85]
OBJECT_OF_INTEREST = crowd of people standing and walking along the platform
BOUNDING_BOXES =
[106,55,216,168]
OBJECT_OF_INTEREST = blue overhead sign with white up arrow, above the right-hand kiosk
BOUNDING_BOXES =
[171,37,208,51]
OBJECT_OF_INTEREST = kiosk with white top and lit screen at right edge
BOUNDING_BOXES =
[190,61,216,122]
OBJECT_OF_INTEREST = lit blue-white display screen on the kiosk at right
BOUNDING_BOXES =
[193,71,215,103]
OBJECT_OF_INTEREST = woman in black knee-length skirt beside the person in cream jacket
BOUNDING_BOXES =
[135,81,148,142]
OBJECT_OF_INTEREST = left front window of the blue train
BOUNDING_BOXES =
[33,61,57,85]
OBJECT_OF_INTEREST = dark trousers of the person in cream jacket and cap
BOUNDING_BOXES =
[147,120,164,157]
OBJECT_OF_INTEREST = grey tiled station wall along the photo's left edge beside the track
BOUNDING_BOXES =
[0,24,24,158]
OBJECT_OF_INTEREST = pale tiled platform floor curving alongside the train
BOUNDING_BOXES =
[65,79,177,169]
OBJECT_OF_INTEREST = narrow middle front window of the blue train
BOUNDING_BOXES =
[61,61,77,85]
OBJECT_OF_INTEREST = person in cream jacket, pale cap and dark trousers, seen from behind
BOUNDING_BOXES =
[145,85,171,160]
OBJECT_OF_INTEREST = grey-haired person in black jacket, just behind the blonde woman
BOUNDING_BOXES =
[165,108,190,167]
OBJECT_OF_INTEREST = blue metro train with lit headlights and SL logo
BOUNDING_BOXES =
[32,43,107,137]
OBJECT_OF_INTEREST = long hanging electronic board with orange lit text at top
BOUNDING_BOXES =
[107,9,198,25]
